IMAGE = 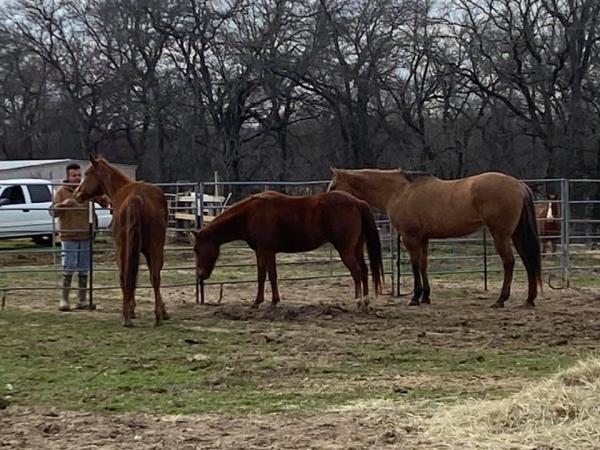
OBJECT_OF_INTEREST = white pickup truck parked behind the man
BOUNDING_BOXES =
[0,178,112,244]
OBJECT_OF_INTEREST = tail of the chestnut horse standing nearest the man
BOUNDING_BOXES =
[122,196,144,291]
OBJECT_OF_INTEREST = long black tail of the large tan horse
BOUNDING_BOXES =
[512,184,542,300]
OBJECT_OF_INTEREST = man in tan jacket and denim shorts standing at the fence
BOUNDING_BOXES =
[51,164,108,311]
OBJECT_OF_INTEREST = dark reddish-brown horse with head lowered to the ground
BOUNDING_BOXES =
[194,188,383,309]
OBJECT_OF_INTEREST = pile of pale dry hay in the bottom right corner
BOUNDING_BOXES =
[418,359,600,450]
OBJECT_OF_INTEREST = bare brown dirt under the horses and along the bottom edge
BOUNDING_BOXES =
[0,280,600,449]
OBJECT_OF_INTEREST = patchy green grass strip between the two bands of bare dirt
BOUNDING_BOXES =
[0,308,582,414]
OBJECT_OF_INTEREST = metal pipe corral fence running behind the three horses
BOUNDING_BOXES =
[0,179,600,308]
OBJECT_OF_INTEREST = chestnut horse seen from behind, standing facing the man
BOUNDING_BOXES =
[74,156,169,327]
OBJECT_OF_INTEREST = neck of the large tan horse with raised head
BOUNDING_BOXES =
[350,173,407,211]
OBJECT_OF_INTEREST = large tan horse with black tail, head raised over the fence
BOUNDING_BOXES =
[329,169,541,307]
